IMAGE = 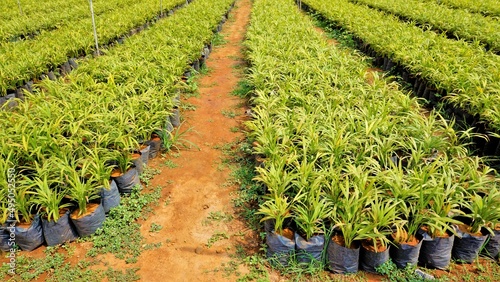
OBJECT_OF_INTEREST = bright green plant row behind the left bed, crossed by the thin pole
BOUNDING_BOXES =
[0,0,186,96]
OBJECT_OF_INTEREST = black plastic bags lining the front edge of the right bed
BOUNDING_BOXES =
[265,224,500,274]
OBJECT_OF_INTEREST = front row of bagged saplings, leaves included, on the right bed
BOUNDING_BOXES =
[259,188,500,274]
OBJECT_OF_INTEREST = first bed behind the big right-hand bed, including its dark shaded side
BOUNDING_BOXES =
[302,1,500,167]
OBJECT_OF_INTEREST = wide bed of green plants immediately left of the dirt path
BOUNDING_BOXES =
[0,0,232,250]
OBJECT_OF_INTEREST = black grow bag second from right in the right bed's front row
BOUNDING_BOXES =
[451,230,488,263]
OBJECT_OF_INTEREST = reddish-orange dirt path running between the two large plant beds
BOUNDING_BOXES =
[134,0,255,281]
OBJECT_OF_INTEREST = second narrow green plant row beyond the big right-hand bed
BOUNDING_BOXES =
[352,0,500,52]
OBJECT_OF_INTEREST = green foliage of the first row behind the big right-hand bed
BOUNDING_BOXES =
[303,0,500,131]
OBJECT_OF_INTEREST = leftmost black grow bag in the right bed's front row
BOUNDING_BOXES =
[266,231,295,266]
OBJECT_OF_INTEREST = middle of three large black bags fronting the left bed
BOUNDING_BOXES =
[42,210,78,246]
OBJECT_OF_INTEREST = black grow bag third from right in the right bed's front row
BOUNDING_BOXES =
[418,229,455,270]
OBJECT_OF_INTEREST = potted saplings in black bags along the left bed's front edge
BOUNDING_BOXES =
[0,109,180,252]
